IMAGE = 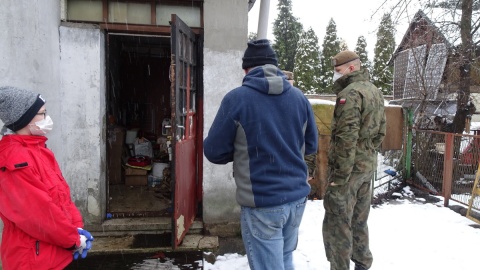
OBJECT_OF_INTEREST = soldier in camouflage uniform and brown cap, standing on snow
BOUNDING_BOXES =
[322,51,386,270]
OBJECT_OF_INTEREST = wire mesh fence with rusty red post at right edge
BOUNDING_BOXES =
[411,129,480,210]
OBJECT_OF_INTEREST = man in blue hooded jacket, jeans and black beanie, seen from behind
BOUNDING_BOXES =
[204,39,318,270]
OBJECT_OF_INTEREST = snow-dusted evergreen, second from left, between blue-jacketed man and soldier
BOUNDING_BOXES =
[294,27,320,94]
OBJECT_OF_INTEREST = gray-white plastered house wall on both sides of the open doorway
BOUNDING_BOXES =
[0,0,253,249]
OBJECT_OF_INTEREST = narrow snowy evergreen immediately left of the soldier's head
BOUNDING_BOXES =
[320,19,340,93]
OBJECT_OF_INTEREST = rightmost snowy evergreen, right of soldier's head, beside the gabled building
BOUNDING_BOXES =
[372,14,395,95]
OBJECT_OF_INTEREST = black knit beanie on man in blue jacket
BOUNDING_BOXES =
[242,39,278,69]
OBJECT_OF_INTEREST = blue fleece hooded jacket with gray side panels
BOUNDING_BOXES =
[204,65,317,207]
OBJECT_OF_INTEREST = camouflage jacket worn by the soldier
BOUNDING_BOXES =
[328,69,386,185]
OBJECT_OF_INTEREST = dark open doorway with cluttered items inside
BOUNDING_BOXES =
[106,33,173,218]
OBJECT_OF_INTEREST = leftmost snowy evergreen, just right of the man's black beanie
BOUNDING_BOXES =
[273,0,303,71]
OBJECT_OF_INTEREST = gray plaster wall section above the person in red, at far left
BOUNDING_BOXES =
[0,0,60,255]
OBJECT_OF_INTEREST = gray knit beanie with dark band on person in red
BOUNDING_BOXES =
[0,86,45,131]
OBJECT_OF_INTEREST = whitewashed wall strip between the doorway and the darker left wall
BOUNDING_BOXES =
[58,23,106,224]
